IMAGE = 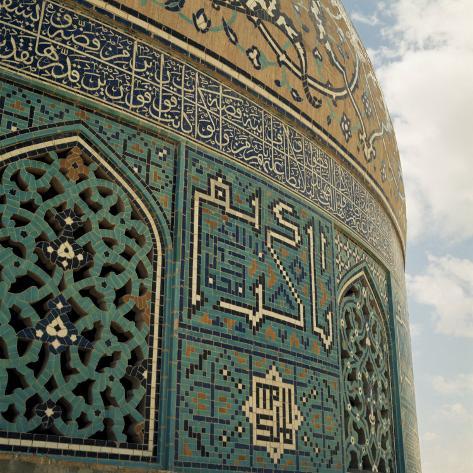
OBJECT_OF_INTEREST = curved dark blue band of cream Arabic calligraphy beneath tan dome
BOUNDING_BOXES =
[0,0,396,264]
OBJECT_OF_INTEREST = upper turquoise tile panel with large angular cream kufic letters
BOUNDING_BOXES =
[180,149,338,370]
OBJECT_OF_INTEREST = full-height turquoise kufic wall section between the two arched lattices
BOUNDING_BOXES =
[174,149,343,472]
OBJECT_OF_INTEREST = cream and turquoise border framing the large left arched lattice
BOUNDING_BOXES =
[0,120,172,461]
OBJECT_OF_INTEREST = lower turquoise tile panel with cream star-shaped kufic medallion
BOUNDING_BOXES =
[174,335,343,473]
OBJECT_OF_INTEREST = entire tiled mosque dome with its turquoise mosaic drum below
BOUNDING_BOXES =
[0,0,421,473]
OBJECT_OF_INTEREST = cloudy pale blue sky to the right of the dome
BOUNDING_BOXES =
[343,0,473,473]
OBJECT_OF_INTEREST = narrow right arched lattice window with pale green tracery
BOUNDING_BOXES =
[340,275,396,473]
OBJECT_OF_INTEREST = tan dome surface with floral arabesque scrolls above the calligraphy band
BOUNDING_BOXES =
[90,0,406,241]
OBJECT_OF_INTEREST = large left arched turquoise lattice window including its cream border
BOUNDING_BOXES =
[0,135,168,461]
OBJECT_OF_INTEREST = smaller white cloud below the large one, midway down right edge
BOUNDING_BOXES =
[407,255,473,338]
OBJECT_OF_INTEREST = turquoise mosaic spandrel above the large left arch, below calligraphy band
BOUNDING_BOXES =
[0,80,175,230]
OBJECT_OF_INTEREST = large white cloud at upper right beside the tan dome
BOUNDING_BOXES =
[376,0,473,241]
